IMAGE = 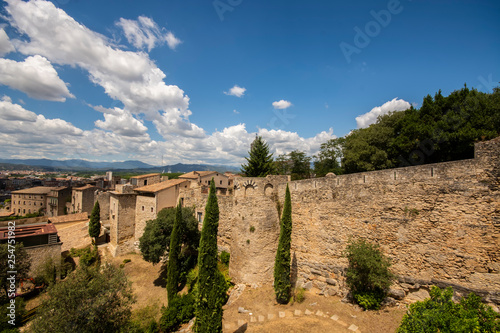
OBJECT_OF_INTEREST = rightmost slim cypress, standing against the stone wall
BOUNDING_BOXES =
[274,184,292,304]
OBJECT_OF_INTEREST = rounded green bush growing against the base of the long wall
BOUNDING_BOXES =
[344,239,394,310]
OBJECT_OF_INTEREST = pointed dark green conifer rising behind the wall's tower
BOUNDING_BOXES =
[241,136,275,177]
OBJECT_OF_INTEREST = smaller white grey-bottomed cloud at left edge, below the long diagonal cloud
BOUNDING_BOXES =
[0,55,75,102]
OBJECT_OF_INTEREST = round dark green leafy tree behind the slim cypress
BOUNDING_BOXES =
[139,207,200,264]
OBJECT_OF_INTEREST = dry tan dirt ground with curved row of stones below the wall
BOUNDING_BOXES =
[223,286,405,333]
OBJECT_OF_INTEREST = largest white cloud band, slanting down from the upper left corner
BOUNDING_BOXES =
[5,0,193,135]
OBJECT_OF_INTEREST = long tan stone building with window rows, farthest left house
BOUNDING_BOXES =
[11,186,54,215]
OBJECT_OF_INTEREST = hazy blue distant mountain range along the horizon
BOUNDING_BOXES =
[0,158,239,172]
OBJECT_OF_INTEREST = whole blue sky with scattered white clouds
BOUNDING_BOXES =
[0,0,500,165]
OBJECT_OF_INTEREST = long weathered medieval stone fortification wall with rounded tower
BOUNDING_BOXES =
[181,138,500,304]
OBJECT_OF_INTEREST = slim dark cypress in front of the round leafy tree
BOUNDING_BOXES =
[167,201,182,304]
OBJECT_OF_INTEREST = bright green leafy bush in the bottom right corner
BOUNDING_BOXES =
[397,287,500,333]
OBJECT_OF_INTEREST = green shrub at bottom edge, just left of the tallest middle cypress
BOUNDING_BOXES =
[160,293,194,332]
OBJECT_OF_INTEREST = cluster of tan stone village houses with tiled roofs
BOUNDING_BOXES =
[4,171,234,255]
